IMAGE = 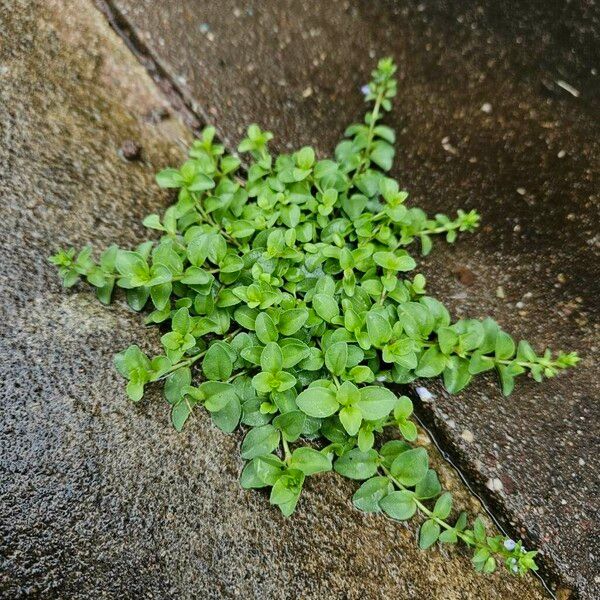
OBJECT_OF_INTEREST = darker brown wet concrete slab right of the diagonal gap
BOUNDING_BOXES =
[104,0,600,598]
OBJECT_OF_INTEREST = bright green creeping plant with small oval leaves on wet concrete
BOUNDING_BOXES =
[50,59,578,573]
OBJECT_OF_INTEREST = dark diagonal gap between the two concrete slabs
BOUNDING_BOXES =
[93,0,571,597]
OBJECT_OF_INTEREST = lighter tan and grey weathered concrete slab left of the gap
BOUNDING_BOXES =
[0,0,544,600]
